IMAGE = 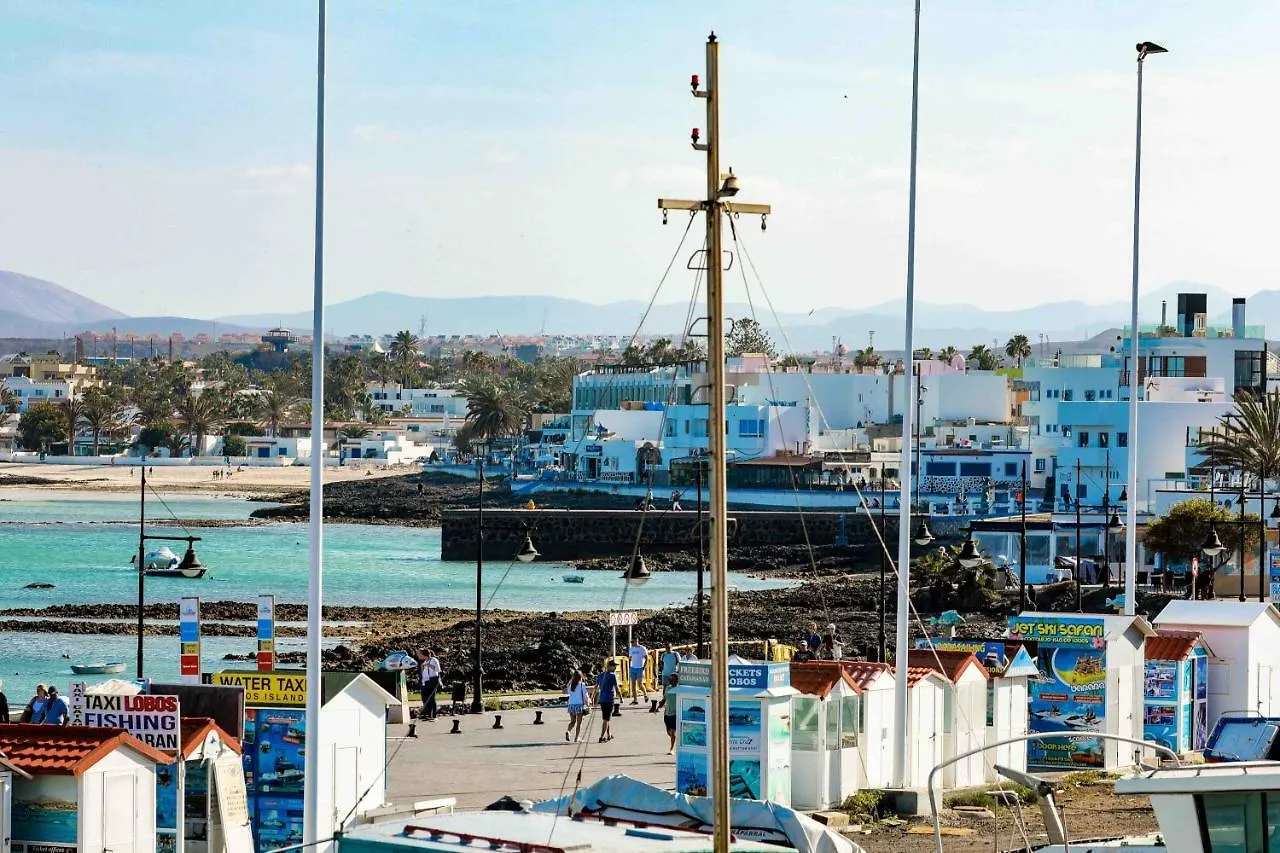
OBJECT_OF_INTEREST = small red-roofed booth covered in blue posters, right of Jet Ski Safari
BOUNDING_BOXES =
[1142,628,1212,754]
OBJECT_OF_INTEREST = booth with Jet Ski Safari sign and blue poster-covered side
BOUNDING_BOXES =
[1009,612,1156,771]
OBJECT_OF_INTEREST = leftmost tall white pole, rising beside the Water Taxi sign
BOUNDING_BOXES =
[302,0,332,848]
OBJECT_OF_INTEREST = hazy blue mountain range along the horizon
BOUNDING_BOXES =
[0,270,1280,352]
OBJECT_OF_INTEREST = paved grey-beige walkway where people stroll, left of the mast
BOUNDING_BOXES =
[387,703,676,808]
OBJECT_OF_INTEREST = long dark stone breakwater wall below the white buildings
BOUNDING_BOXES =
[440,508,964,561]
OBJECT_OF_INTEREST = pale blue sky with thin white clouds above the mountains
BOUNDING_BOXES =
[0,0,1280,318]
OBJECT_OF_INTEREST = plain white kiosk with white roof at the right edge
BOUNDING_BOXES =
[1155,601,1280,731]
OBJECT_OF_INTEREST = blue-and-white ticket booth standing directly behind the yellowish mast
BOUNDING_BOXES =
[676,657,796,806]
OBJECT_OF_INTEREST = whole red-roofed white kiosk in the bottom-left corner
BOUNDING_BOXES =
[0,724,173,853]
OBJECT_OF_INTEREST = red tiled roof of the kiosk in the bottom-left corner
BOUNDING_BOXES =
[0,722,173,776]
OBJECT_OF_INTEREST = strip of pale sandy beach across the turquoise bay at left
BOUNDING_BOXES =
[0,462,419,497]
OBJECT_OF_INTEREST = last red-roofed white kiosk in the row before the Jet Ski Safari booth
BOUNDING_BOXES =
[906,648,989,789]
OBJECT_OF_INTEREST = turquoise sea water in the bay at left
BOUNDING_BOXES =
[0,491,786,702]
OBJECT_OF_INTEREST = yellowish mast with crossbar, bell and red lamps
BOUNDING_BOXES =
[658,32,769,853]
